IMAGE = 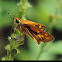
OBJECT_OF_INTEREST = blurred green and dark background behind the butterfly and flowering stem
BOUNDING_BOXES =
[0,0,62,60]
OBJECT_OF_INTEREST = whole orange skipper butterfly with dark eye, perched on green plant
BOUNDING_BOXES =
[14,17,54,44]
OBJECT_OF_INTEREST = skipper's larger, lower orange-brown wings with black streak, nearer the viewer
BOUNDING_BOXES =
[23,24,54,44]
